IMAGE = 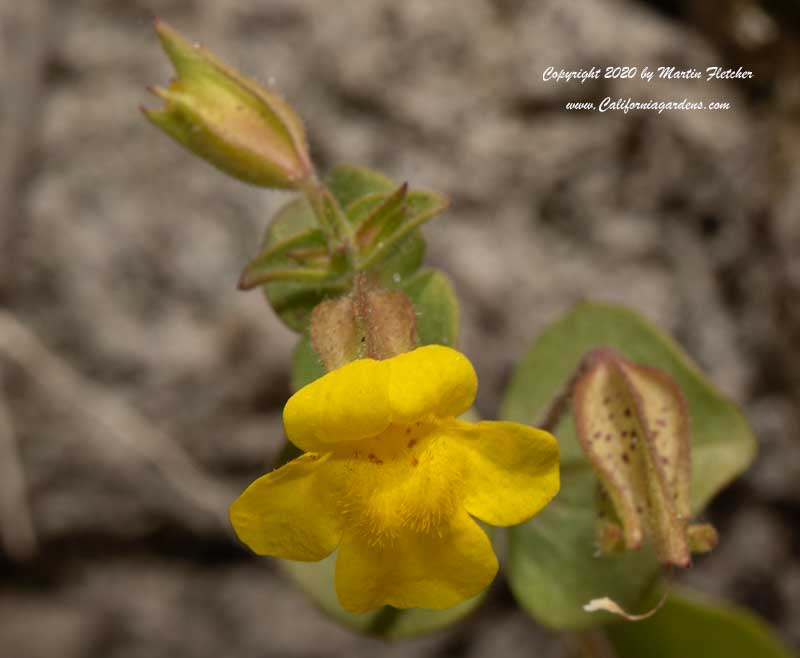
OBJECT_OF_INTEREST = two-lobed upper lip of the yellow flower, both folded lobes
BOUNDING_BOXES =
[283,345,478,452]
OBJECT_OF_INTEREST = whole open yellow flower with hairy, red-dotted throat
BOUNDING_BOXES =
[231,345,559,613]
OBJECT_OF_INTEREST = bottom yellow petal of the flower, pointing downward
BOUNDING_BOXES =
[336,512,497,613]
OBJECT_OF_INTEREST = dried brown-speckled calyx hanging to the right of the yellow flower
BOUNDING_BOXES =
[574,348,717,567]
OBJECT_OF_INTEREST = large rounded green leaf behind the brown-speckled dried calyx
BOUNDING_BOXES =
[501,304,756,629]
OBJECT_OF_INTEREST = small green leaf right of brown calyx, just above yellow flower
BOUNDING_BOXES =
[401,269,459,347]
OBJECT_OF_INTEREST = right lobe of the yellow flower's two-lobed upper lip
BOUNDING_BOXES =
[386,345,478,424]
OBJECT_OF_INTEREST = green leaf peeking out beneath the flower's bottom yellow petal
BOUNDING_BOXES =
[279,553,484,639]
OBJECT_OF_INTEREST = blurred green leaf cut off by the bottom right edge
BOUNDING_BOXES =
[607,590,793,658]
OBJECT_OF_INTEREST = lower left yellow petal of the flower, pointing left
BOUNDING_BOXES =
[230,454,342,562]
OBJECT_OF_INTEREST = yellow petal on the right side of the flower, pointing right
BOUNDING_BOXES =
[454,421,559,526]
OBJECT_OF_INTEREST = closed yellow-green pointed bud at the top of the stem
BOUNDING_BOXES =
[143,21,313,188]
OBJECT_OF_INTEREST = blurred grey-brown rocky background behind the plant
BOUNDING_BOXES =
[0,0,800,658]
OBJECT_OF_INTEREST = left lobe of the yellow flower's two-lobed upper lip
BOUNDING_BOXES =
[283,359,391,452]
